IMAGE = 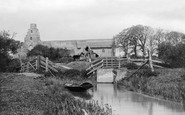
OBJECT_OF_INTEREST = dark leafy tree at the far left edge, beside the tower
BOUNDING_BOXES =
[0,31,20,72]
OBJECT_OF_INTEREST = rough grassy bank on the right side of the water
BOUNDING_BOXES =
[118,68,185,103]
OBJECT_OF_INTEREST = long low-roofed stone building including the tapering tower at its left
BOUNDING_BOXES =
[19,24,113,57]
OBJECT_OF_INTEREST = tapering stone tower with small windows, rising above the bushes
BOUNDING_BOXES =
[24,24,41,50]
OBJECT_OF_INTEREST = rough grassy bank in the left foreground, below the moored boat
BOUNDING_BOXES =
[0,73,112,115]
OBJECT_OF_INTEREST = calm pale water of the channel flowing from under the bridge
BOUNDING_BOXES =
[69,84,185,115]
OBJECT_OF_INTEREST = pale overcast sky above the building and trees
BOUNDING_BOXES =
[0,0,185,41]
